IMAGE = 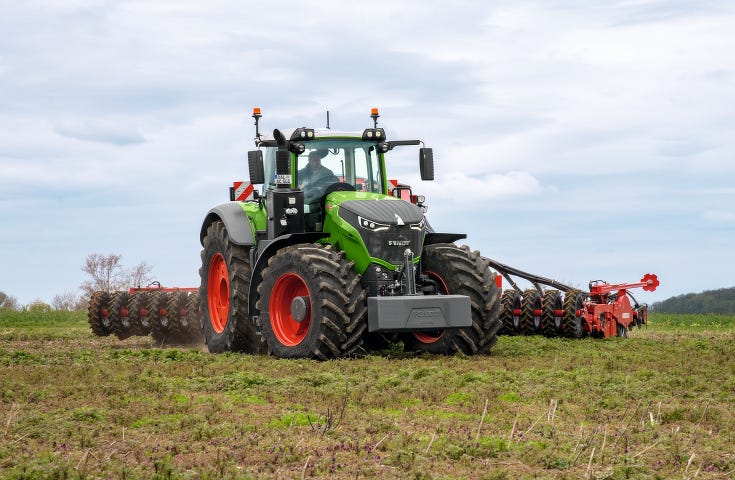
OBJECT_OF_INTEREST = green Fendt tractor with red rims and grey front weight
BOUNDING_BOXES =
[199,108,501,359]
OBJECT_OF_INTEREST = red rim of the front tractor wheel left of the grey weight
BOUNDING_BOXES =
[269,273,311,347]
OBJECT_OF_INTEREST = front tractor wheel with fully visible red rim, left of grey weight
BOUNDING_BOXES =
[257,243,367,360]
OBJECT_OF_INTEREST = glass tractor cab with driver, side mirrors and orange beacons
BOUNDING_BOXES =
[248,109,434,238]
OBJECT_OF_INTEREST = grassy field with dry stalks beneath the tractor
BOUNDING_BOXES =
[0,312,735,479]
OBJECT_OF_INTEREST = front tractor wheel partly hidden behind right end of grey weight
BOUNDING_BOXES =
[402,243,501,355]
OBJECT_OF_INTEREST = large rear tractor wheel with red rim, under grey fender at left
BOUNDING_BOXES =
[200,221,262,353]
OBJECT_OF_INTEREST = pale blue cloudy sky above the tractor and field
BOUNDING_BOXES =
[0,0,735,304]
